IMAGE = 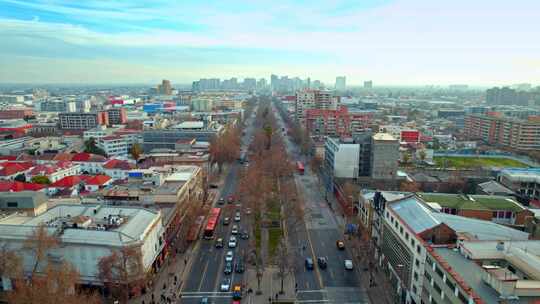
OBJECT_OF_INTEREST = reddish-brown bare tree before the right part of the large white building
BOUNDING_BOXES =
[98,247,144,303]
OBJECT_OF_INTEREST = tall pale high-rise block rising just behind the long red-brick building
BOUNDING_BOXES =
[295,89,339,124]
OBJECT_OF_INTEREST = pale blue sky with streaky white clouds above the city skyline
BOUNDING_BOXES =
[0,0,540,85]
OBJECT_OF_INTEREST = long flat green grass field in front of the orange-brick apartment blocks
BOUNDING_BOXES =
[434,156,527,169]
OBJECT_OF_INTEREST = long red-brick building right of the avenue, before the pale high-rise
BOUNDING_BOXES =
[305,105,373,137]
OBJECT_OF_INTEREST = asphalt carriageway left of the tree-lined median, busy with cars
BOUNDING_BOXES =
[179,107,256,304]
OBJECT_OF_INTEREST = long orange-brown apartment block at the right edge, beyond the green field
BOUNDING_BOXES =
[465,112,540,150]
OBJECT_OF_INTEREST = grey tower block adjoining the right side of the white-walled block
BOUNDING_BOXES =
[371,133,399,179]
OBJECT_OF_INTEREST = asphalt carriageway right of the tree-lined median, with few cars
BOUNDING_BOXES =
[272,104,368,304]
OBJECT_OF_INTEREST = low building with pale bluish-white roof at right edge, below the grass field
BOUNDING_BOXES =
[497,168,540,201]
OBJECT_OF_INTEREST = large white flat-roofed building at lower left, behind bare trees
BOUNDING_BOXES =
[0,205,165,285]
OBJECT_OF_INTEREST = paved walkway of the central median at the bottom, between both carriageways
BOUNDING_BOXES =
[243,267,296,304]
